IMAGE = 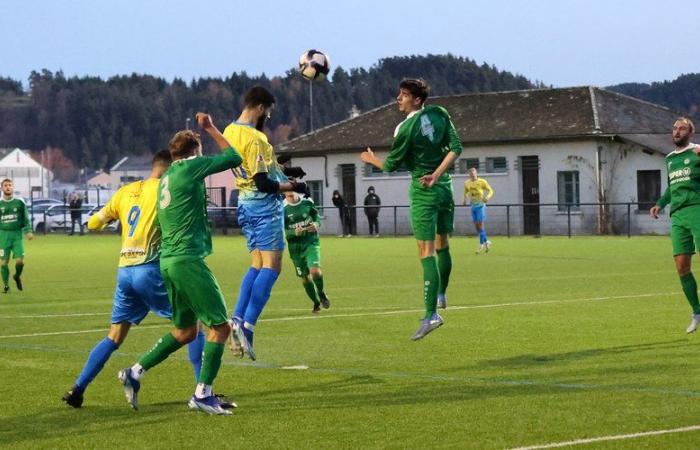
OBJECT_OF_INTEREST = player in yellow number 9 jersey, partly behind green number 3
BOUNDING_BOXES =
[63,150,211,408]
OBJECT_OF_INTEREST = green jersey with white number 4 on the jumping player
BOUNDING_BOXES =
[382,105,462,184]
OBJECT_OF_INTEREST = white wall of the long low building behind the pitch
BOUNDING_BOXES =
[292,139,667,239]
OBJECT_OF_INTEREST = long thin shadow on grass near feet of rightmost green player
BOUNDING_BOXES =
[480,339,695,367]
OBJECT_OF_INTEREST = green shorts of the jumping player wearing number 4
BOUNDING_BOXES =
[409,180,455,241]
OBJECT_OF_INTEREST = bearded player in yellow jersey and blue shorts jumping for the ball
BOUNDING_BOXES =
[224,86,307,360]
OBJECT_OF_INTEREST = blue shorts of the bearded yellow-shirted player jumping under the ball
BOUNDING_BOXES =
[238,196,284,251]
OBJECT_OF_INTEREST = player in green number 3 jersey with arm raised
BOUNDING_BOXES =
[119,113,242,414]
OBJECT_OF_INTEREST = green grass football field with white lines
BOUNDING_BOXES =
[0,236,700,449]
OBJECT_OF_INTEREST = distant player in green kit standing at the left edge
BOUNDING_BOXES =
[0,178,34,294]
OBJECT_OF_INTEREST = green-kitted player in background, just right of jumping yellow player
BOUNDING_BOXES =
[284,192,331,314]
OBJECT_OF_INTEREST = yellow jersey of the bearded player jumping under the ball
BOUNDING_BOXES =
[224,122,287,201]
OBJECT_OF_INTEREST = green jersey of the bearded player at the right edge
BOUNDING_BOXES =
[657,144,700,214]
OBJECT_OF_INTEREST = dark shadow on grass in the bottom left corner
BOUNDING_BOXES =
[0,402,170,448]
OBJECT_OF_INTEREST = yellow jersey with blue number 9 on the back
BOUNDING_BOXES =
[88,178,160,267]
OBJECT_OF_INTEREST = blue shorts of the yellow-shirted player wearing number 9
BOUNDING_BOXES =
[112,261,173,325]
